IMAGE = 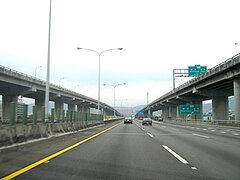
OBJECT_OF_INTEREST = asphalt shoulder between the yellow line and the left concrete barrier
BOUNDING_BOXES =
[0,121,121,177]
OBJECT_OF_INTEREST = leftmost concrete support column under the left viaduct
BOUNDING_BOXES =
[2,95,18,122]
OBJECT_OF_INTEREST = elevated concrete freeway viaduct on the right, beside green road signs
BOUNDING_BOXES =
[141,54,240,120]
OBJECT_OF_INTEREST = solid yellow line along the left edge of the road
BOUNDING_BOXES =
[1,123,121,180]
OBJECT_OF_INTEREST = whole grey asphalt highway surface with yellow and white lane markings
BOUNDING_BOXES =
[0,120,240,180]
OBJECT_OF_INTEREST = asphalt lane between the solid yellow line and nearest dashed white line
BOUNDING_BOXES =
[17,121,204,179]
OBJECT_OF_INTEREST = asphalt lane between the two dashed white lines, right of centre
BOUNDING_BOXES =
[137,119,240,179]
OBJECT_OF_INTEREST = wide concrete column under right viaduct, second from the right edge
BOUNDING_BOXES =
[212,96,229,120]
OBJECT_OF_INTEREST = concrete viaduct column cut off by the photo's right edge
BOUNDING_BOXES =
[233,78,240,120]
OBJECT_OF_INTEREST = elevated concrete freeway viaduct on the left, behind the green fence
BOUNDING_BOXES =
[0,66,120,121]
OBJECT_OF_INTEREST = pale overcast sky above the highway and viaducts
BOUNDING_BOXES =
[0,0,240,106]
